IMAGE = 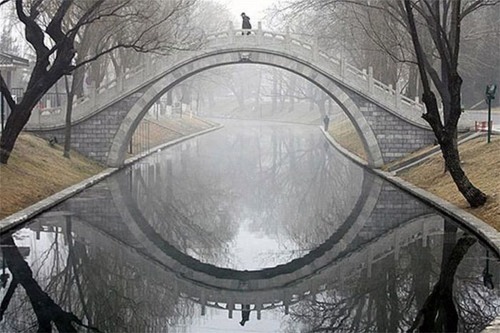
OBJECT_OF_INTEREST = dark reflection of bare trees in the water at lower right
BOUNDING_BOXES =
[284,223,499,332]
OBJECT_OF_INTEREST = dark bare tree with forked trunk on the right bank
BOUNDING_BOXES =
[395,0,498,207]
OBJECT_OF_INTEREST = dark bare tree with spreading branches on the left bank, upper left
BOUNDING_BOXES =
[0,0,196,164]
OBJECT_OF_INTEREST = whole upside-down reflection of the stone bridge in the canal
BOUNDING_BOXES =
[27,162,443,317]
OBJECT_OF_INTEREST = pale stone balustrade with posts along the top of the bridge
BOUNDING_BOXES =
[28,22,427,128]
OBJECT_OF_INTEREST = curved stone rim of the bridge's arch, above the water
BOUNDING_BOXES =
[108,46,384,166]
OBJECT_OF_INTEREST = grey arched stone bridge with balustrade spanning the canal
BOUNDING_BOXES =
[26,24,434,167]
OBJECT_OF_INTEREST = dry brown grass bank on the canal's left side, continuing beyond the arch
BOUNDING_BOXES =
[0,118,212,219]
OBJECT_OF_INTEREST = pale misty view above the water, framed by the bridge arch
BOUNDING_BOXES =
[162,63,338,120]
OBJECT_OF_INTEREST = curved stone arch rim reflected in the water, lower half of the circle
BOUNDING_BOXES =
[108,165,382,290]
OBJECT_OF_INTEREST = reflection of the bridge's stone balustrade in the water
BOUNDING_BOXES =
[63,197,444,316]
